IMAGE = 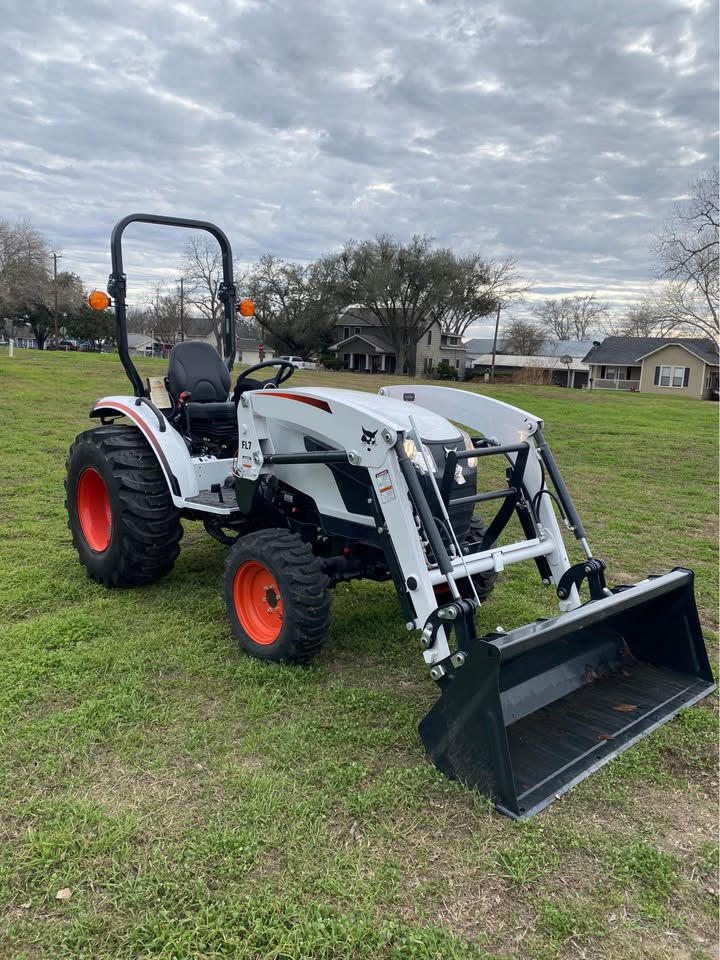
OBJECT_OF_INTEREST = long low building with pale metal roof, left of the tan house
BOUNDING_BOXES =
[473,340,592,390]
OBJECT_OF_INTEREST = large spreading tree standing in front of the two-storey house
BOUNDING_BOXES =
[335,234,457,376]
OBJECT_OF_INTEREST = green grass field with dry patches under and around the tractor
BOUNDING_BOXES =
[0,351,718,960]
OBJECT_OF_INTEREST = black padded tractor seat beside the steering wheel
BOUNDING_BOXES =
[167,340,237,422]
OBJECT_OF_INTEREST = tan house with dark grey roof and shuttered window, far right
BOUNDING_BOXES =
[585,337,718,400]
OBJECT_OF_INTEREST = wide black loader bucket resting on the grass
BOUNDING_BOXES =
[419,569,715,820]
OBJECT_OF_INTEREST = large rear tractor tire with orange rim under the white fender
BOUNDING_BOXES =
[65,426,183,587]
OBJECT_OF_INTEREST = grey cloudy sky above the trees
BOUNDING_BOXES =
[0,0,718,334]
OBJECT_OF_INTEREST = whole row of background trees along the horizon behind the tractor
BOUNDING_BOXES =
[0,169,720,360]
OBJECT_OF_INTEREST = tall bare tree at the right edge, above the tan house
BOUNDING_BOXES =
[655,167,720,343]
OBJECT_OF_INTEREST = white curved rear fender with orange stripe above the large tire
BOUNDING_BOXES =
[90,396,200,507]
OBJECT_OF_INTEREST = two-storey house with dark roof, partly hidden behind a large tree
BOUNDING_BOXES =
[329,307,467,380]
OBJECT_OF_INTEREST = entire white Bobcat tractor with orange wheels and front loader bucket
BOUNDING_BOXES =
[66,214,714,819]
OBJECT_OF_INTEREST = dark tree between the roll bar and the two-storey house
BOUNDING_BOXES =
[245,254,340,357]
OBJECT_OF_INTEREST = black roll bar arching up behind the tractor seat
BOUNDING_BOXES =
[107,213,236,397]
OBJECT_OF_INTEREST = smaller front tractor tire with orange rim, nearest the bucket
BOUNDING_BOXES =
[225,528,330,663]
